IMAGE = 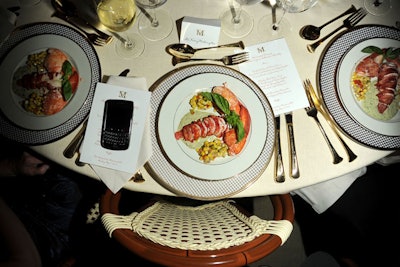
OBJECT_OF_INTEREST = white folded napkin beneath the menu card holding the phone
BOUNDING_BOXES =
[85,76,152,193]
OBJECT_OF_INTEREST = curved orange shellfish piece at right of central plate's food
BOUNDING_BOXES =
[223,105,251,156]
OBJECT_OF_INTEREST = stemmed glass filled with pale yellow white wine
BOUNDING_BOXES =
[97,0,144,58]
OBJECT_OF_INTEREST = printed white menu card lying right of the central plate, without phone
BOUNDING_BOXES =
[239,39,309,116]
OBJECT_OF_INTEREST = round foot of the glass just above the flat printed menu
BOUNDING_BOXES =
[258,15,292,40]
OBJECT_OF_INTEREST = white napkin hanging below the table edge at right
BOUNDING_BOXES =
[291,167,367,213]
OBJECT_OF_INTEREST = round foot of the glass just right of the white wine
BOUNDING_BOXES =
[138,10,173,41]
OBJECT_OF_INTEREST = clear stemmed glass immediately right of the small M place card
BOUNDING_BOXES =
[220,0,263,38]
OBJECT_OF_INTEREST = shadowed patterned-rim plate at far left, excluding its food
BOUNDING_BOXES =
[0,23,101,145]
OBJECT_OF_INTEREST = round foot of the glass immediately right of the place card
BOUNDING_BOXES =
[221,10,254,38]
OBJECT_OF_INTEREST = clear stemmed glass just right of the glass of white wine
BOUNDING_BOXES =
[135,0,173,41]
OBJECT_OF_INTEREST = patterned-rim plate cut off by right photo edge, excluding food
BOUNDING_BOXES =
[317,25,400,150]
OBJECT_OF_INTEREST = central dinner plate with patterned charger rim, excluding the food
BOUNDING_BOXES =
[145,64,275,199]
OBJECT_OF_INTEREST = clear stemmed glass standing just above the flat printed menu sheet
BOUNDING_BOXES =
[258,0,292,39]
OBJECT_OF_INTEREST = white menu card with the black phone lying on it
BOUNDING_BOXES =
[80,83,151,174]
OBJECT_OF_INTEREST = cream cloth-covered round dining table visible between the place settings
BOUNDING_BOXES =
[2,0,400,201]
